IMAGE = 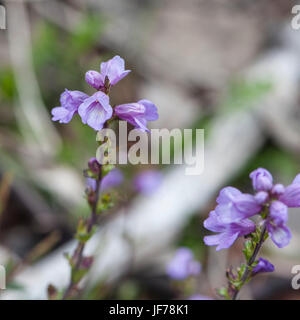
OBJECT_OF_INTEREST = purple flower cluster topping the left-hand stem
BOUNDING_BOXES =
[52,56,158,131]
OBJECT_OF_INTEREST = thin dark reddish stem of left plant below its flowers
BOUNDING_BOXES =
[62,167,102,300]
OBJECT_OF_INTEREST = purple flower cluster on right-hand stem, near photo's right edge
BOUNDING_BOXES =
[204,168,300,250]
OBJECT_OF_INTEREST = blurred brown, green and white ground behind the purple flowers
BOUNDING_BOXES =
[0,0,300,299]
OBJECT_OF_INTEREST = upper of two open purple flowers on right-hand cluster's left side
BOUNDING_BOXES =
[215,187,261,223]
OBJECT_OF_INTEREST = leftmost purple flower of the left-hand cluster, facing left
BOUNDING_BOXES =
[51,89,89,123]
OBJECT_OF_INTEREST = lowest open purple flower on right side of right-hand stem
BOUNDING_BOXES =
[266,200,292,248]
